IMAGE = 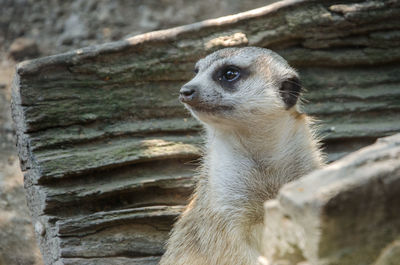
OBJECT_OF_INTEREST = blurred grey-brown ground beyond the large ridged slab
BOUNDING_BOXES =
[0,0,275,265]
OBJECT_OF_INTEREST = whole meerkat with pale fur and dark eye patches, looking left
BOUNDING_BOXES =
[160,47,323,265]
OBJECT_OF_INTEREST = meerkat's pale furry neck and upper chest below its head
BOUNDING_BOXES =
[204,112,322,216]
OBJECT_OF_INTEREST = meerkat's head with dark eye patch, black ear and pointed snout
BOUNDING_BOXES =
[179,47,301,129]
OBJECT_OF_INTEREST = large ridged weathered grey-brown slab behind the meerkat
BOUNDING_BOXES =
[13,0,400,264]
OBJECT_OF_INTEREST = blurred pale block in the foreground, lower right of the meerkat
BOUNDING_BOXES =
[264,134,400,265]
